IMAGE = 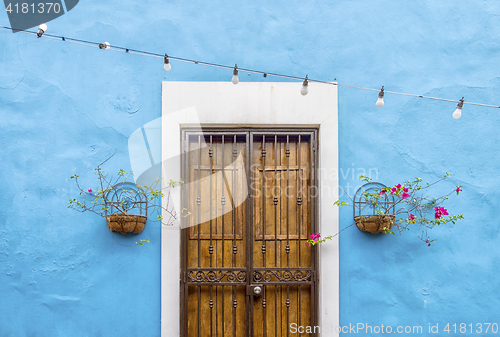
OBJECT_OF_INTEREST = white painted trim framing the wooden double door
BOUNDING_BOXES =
[161,82,339,337]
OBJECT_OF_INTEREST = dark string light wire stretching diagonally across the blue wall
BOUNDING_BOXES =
[0,25,500,108]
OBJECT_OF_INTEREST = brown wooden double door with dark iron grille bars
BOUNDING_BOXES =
[181,129,318,337]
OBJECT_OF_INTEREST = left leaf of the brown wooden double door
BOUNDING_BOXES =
[185,135,248,336]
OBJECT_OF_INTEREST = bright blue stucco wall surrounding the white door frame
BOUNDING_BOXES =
[0,0,500,337]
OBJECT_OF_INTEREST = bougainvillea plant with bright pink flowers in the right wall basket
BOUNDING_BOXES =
[305,173,464,247]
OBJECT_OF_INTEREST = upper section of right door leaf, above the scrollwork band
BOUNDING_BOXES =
[251,137,311,240]
